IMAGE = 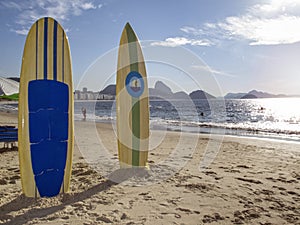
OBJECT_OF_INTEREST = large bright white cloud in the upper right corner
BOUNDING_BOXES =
[181,0,300,45]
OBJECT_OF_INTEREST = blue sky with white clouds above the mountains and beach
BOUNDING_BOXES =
[0,0,300,96]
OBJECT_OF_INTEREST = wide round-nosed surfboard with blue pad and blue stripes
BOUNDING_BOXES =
[18,17,74,197]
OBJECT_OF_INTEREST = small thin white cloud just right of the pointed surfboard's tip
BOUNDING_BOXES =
[151,37,212,47]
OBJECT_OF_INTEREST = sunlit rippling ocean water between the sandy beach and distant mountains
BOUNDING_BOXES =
[0,98,300,141]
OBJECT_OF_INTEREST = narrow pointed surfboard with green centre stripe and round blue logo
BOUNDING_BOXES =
[116,23,149,168]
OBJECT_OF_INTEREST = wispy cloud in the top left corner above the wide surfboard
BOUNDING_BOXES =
[0,0,101,35]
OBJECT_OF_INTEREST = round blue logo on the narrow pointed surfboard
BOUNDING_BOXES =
[125,71,145,98]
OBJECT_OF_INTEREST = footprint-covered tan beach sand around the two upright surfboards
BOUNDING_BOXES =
[0,112,300,225]
